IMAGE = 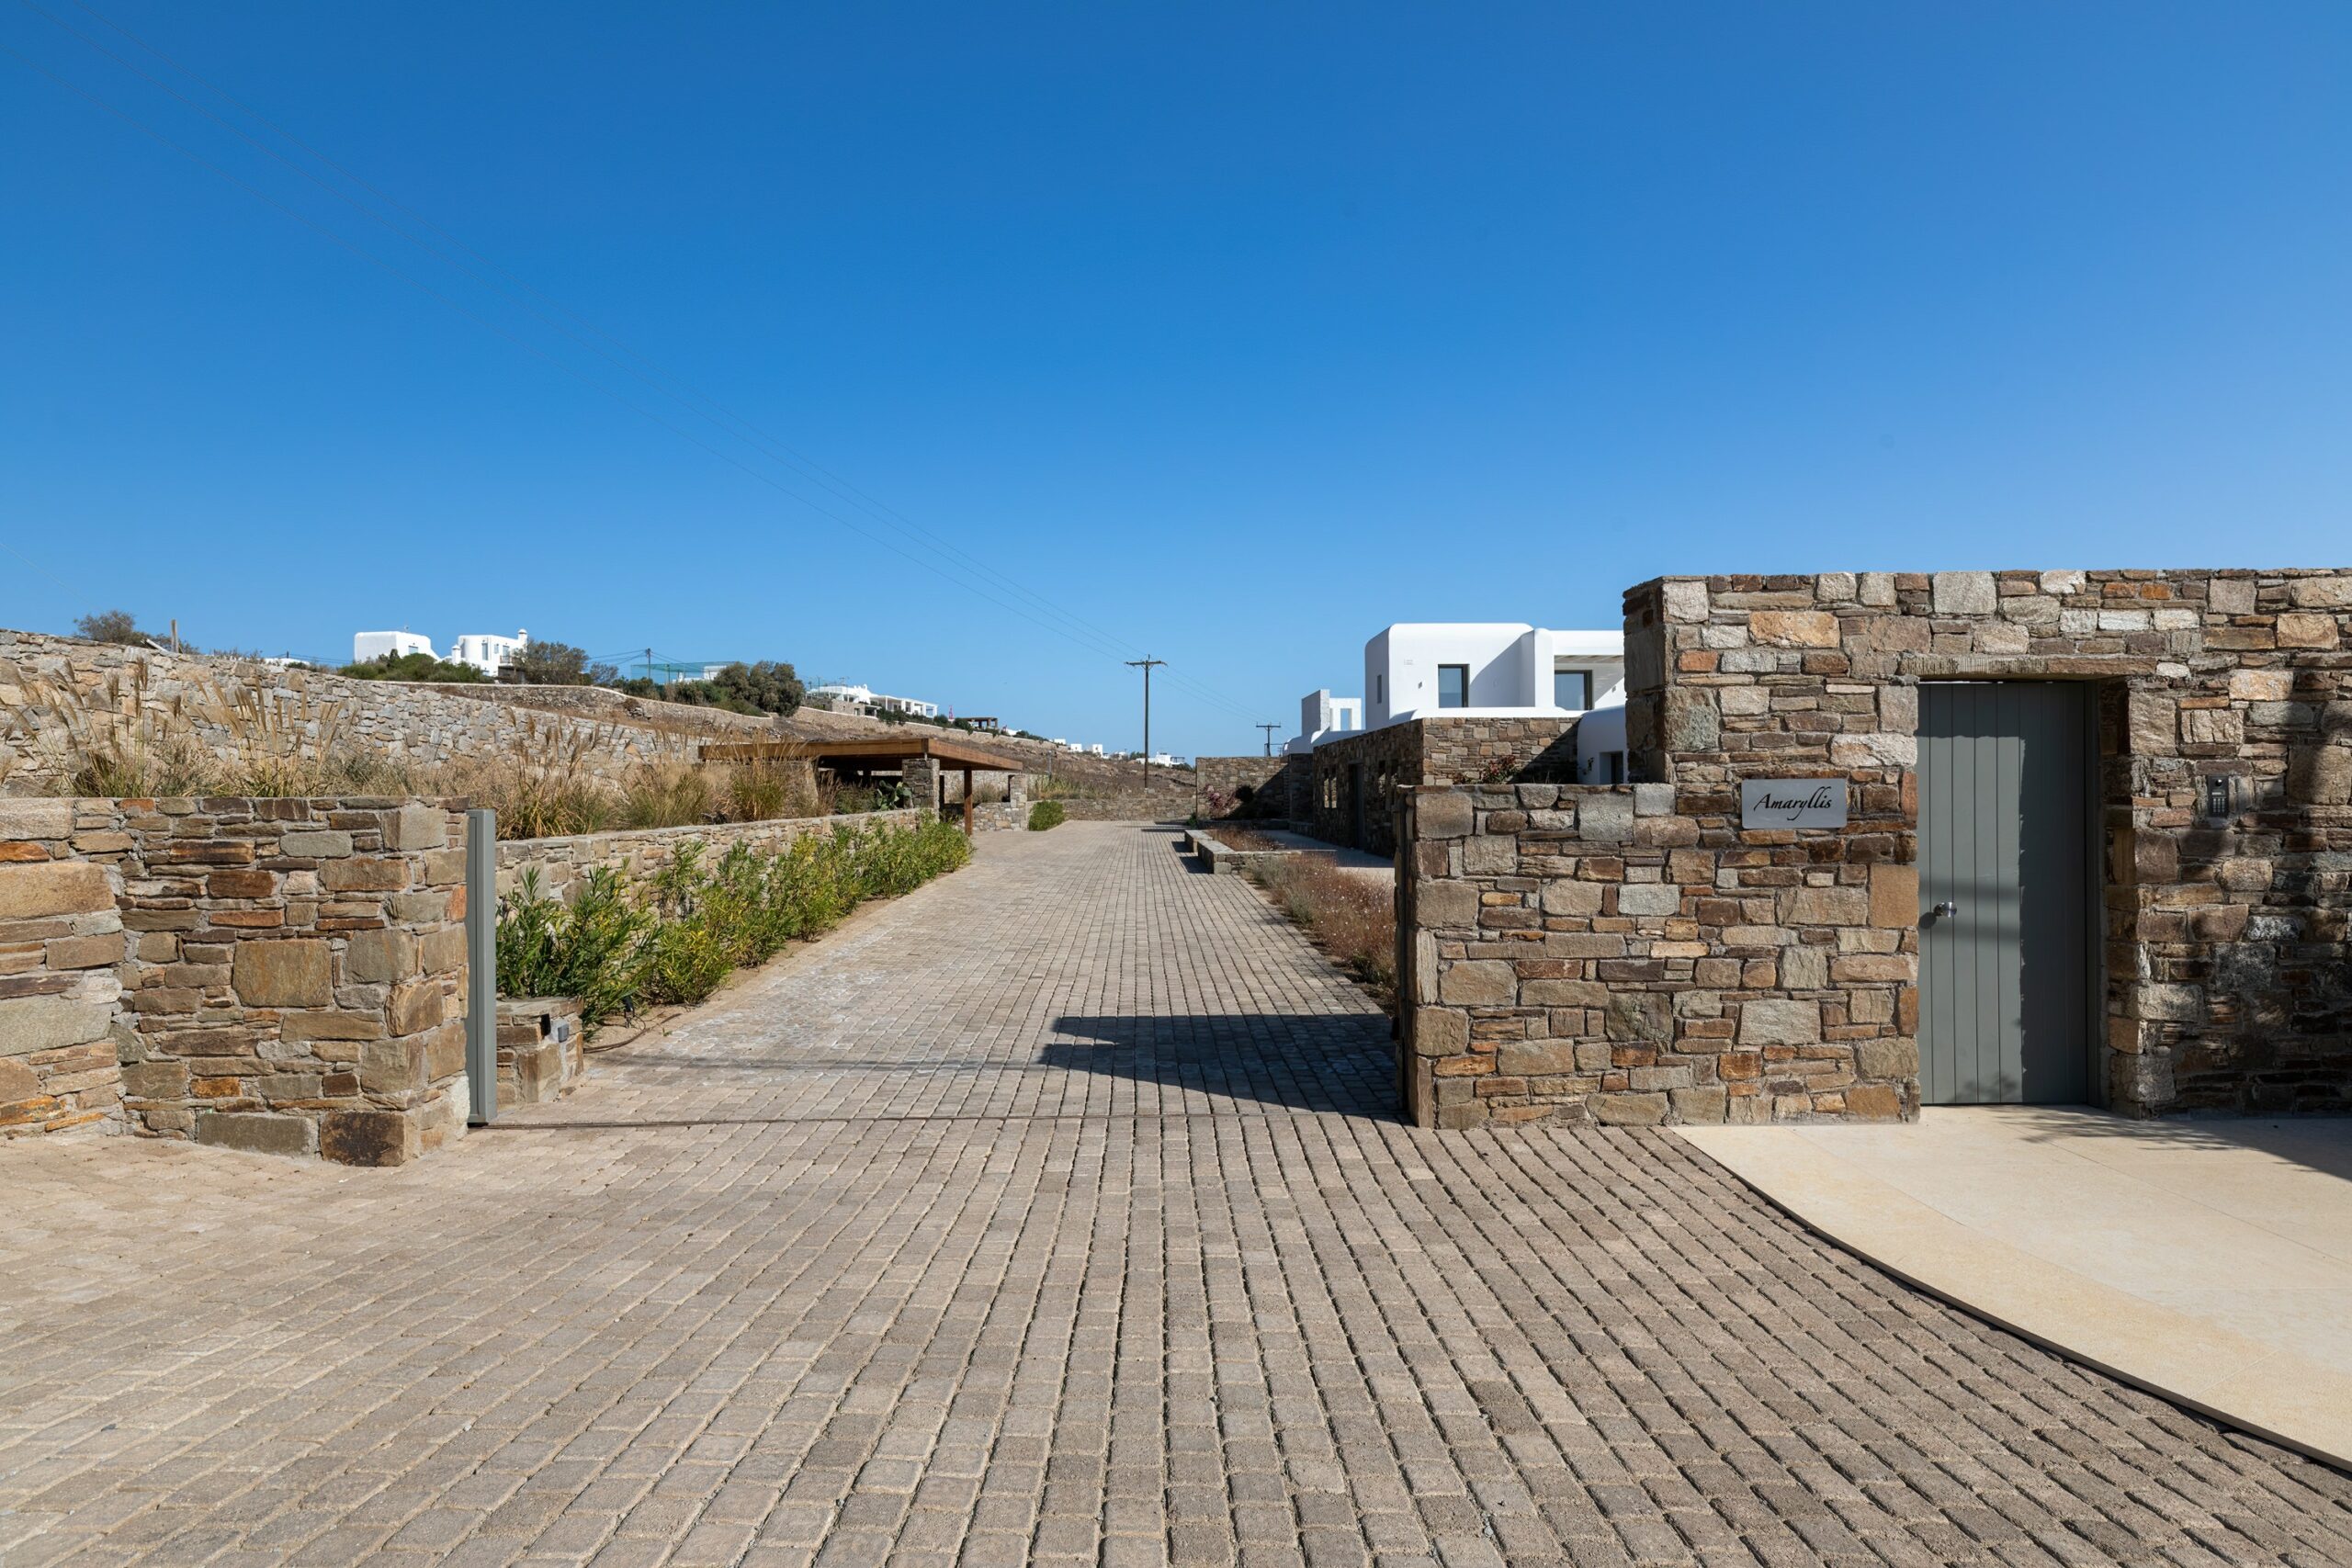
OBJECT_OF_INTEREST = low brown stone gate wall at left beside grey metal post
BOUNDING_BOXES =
[0,797,466,1164]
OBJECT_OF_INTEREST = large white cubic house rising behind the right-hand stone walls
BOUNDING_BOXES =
[1364,621,1625,728]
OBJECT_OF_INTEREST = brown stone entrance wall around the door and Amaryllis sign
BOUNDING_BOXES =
[1399,569,2352,1122]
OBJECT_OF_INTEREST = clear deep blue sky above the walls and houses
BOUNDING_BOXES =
[0,0,2352,752]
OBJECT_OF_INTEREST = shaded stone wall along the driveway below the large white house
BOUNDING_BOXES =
[1291,719,1576,856]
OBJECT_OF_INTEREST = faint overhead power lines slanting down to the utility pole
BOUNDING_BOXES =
[18,0,1247,712]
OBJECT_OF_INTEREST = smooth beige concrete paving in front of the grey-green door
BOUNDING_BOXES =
[1681,1105,2352,1467]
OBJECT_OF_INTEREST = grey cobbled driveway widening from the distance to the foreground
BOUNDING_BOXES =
[0,823,2352,1568]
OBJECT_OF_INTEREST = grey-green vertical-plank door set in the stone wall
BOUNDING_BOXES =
[1919,682,2096,1105]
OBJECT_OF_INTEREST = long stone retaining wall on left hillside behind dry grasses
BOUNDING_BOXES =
[0,630,710,795]
